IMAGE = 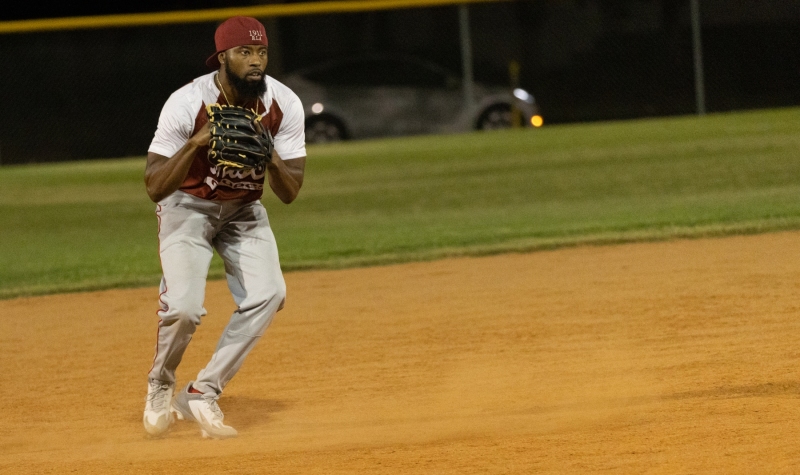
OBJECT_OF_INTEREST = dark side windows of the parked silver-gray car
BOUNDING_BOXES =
[305,59,452,88]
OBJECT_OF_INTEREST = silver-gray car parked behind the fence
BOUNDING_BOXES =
[279,55,542,143]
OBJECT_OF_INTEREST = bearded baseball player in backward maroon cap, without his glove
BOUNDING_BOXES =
[144,17,306,439]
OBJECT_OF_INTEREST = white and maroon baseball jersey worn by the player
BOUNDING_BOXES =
[148,72,306,201]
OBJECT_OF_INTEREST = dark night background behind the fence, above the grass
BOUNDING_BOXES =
[0,0,800,164]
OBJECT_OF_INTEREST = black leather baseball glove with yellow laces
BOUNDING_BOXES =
[206,104,273,171]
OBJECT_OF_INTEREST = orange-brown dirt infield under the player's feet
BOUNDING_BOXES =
[0,232,800,474]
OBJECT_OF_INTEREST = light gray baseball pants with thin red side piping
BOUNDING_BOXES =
[148,191,286,394]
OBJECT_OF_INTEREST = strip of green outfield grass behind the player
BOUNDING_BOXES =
[0,108,800,298]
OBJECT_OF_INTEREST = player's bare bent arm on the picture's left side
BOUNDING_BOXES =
[144,123,211,203]
